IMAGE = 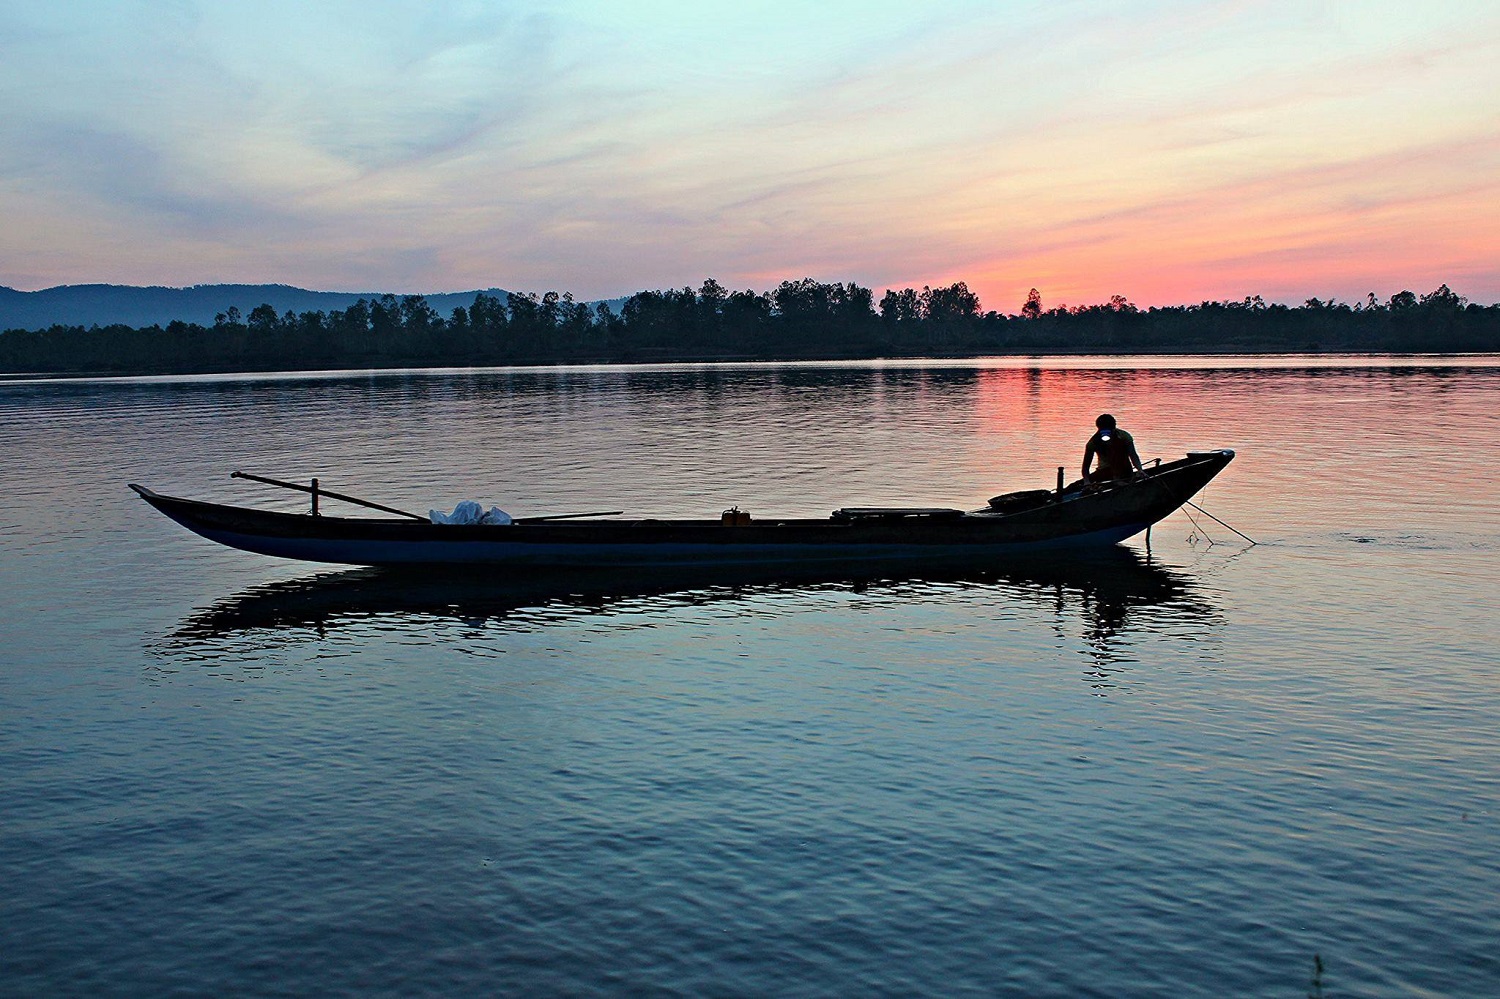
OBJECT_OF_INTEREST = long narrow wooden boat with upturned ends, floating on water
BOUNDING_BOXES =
[131,449,1235,567]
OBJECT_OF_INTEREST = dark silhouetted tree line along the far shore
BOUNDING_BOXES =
[0,278,1500,374]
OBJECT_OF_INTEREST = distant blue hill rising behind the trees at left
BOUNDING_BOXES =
[0,285,522,330]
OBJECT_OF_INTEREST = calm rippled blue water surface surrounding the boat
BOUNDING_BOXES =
[0,359,1500,998]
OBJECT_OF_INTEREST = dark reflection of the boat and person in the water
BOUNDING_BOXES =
[155,548,1218,687]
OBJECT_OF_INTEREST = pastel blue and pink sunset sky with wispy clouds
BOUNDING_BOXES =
[0,0,1500,312]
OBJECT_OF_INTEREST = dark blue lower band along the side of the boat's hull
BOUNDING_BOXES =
[183,524,1149,567]
